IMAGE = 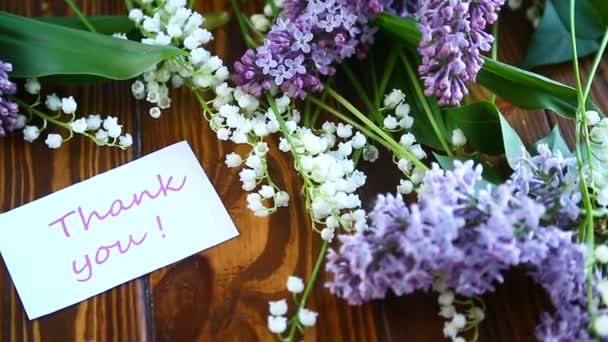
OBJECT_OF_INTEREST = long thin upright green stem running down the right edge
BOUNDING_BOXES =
[570,0,595,321]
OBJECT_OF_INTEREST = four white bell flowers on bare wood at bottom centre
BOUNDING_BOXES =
[268,276,318,334]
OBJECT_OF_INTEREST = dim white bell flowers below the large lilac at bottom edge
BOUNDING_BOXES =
[433,278,485,342]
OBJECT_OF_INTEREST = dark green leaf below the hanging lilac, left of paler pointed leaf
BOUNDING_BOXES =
[443,102,504,155]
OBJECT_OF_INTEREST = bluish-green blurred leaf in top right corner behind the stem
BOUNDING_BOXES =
[522,0,603,69]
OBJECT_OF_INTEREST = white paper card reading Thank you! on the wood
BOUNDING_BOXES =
[0,141,238,319]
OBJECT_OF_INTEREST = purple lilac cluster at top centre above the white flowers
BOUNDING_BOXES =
[234,0,383,97]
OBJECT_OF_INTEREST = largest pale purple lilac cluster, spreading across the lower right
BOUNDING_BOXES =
[326,145,590,341]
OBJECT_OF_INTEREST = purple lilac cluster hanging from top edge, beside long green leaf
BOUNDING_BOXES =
[418,0,505,105]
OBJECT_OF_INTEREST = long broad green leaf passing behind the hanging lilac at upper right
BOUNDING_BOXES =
[376,13,596,119]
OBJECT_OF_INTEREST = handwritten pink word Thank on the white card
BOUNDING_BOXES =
[49,175,186,237]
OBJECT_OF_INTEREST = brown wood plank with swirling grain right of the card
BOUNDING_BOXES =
[142,1,377,341]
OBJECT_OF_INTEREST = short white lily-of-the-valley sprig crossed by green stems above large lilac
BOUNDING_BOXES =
[382,89,427,194]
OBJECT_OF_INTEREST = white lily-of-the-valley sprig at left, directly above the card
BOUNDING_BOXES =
[17,79,133,149]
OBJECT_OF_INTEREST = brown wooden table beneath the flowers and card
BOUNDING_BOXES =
[0,0,608,342]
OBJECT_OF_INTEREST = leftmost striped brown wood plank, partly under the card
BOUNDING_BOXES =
[0,0,147,341]
